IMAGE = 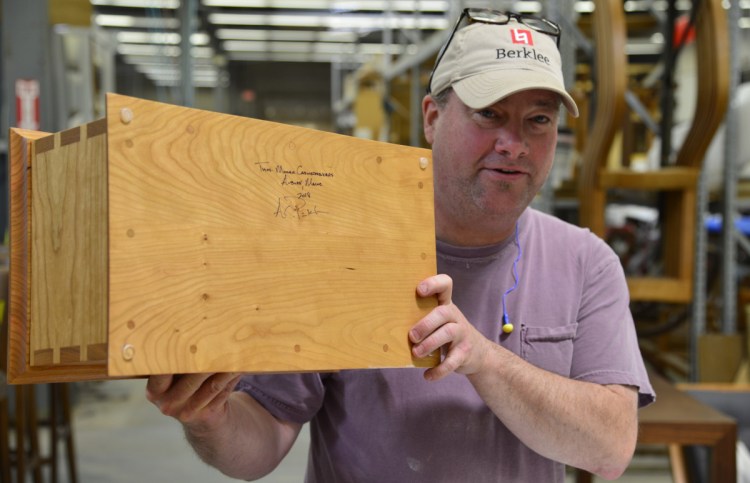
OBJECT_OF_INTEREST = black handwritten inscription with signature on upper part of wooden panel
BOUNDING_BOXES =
[255,161,335,220]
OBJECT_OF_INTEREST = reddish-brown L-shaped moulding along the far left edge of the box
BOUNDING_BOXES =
[8,128,107,384]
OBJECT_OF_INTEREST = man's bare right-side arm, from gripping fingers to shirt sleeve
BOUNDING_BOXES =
[409,275,638,479]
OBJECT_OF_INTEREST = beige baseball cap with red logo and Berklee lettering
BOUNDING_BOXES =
[431,19,578,117]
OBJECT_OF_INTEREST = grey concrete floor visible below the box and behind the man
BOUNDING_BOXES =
[55,380,671,483]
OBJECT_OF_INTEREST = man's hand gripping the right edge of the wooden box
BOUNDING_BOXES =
[409,275,492,381]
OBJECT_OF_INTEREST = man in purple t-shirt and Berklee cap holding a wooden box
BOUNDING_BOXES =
[147,9,654,483]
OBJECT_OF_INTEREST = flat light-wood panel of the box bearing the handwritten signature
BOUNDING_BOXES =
[107,95,436,376]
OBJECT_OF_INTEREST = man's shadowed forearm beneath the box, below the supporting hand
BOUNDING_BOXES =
[183,392,299,480]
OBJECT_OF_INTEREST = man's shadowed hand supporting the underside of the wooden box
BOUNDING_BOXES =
[146,373,241,430]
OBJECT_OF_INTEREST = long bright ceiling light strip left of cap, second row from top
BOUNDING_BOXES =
[208,13,449,30]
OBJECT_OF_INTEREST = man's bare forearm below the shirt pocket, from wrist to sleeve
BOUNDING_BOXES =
[468,345,638,478]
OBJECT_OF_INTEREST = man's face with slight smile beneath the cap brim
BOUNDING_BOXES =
[423,89,560,242]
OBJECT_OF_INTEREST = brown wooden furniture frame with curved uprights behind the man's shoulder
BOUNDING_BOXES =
[578,0,729,303]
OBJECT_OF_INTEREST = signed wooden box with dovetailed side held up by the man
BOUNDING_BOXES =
[8,94,436,383]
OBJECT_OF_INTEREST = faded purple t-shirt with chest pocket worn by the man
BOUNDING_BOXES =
[239,209,654,483]
